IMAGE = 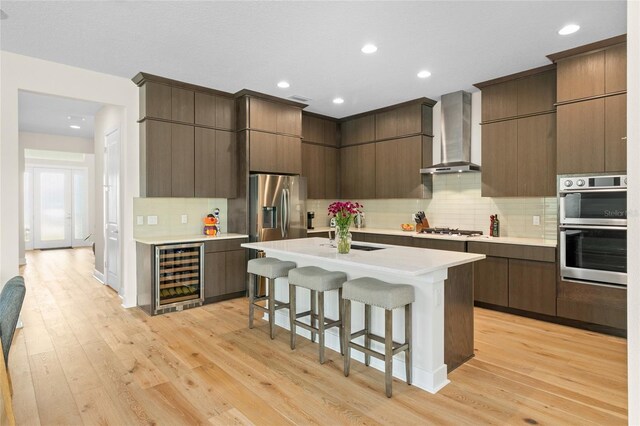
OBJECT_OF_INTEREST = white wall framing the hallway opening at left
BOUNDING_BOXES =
[0,51,139,307]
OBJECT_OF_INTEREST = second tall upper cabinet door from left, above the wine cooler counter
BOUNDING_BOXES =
[171,123,195,198]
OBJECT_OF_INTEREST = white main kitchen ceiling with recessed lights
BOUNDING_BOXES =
[0,0,626,117]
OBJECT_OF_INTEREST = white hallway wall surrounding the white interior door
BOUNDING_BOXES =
[93,105,125,279]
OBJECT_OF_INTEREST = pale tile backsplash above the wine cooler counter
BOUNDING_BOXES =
[133,198,227,238]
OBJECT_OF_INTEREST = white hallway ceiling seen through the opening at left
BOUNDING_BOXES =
[18,91,102,140]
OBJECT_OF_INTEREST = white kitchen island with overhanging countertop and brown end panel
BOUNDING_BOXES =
[242,238,485,393]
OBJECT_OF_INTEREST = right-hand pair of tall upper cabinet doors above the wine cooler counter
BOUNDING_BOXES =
[194,127,237,198]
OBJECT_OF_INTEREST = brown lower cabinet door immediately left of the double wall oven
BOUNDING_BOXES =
[508,259,556,315]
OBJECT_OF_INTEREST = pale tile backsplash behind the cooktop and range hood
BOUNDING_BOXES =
[307,173,558,240]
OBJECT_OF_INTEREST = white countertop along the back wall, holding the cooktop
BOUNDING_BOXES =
[307,226,558,247]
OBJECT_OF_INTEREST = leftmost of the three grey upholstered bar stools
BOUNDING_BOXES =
[247,257,296,339]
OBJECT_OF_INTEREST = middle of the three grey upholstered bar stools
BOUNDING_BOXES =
[289,266,347,364]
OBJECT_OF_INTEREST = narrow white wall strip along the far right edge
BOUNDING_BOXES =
[627,1,640,425]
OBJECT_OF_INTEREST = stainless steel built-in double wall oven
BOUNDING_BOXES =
[558,175,627,286]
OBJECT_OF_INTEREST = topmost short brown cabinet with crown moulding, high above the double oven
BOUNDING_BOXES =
[548,35,627,103]
